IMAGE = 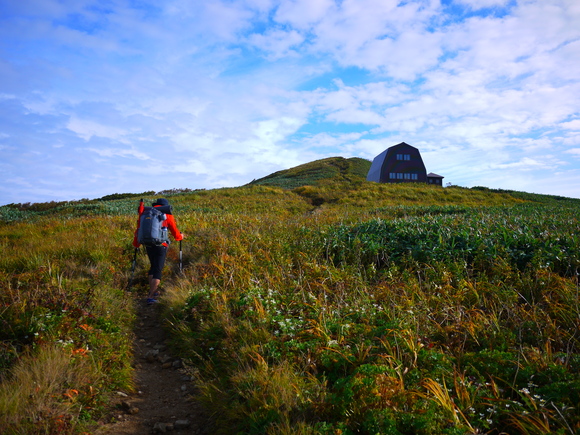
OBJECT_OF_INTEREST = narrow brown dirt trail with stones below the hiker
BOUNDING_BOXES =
[94,298,207,435]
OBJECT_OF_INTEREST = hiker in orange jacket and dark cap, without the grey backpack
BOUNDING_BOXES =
[133,198,184,305]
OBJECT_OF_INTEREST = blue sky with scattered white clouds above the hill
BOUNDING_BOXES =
[0,0,580,205]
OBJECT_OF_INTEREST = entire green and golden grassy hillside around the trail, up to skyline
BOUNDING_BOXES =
[0,158,580,435]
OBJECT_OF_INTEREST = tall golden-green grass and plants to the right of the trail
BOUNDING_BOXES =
[159,185,580,434]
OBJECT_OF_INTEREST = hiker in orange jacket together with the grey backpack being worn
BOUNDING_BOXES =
[133,198,184,305]
